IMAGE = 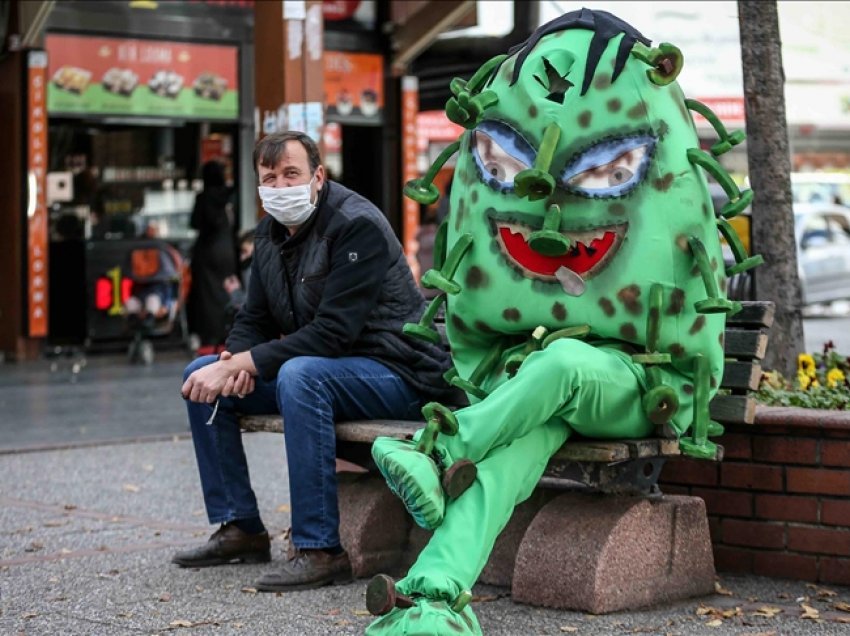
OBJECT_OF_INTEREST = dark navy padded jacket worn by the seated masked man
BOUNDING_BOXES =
[222,182,451,399]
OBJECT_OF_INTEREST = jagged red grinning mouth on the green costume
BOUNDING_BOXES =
[497,223,626,278]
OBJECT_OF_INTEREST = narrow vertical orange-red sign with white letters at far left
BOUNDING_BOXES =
[26,51,48,338]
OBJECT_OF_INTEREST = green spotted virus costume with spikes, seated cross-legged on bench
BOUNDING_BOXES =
[367,9,760,634]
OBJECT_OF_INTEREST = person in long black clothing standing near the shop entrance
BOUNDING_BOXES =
[189,161,239,347]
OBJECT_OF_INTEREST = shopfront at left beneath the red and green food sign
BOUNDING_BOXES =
[44,2,256,345]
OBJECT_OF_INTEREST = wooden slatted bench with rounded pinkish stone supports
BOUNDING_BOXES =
[241,302,774,613]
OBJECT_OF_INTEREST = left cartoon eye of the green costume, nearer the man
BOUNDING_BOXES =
[473,121,534,188]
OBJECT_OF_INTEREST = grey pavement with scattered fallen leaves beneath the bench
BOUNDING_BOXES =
[0,352,850,636]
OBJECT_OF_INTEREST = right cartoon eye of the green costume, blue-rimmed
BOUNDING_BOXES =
[561,135,655,197]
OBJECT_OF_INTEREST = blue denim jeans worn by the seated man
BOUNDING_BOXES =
[183,356,421,549]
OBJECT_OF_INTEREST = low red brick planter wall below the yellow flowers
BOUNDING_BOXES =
[661,409,850,585]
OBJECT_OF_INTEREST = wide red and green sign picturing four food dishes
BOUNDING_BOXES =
[45,34,239,119]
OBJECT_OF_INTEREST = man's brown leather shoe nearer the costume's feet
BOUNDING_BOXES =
[255,545,354,592]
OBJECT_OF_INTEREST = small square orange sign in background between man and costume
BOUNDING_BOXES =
[325,51,384,124]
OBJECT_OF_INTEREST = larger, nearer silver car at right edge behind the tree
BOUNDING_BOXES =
[794,201,850,305]
